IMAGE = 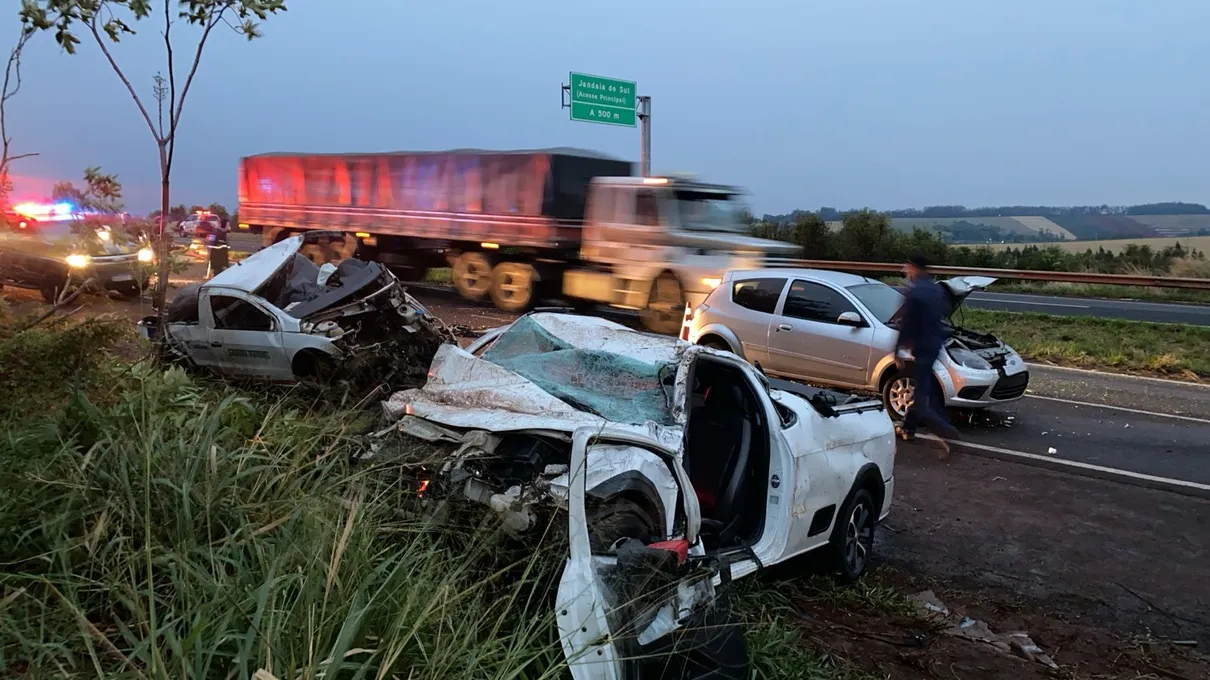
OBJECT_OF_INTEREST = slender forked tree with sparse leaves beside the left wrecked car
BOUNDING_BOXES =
[21,0,286,319]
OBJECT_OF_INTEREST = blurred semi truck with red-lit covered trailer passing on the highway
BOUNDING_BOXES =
[238,148,800,334]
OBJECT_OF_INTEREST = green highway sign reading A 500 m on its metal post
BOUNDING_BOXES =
[563,71,651,177]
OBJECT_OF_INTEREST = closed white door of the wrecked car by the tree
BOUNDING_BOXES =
[200,289,293,380]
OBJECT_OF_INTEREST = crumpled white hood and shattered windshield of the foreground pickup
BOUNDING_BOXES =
[382,313,702,450]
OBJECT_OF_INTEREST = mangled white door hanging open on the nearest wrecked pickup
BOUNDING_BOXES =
[555,427,747,680]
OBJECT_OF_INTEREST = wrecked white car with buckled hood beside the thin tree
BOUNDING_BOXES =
[139,234,453,387]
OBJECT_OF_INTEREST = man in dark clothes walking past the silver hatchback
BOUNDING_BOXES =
[895,255,958,460]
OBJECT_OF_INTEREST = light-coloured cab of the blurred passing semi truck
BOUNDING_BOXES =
[563,177,800,334]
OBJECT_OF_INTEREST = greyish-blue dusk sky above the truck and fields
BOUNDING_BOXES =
[0,0,1210,214]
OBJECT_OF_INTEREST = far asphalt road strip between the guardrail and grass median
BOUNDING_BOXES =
[967,292,1210,325]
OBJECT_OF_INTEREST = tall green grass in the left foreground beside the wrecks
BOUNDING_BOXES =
[0,367,561,679]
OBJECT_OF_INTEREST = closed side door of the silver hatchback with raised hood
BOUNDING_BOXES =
[768,278,874,387]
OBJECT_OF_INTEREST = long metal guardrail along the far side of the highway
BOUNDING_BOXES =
[766,259,1210,290]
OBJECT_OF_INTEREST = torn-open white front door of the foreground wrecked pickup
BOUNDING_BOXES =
[555,427,719,680]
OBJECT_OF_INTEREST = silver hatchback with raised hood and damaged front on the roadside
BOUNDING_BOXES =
[681,269,1030,420]
